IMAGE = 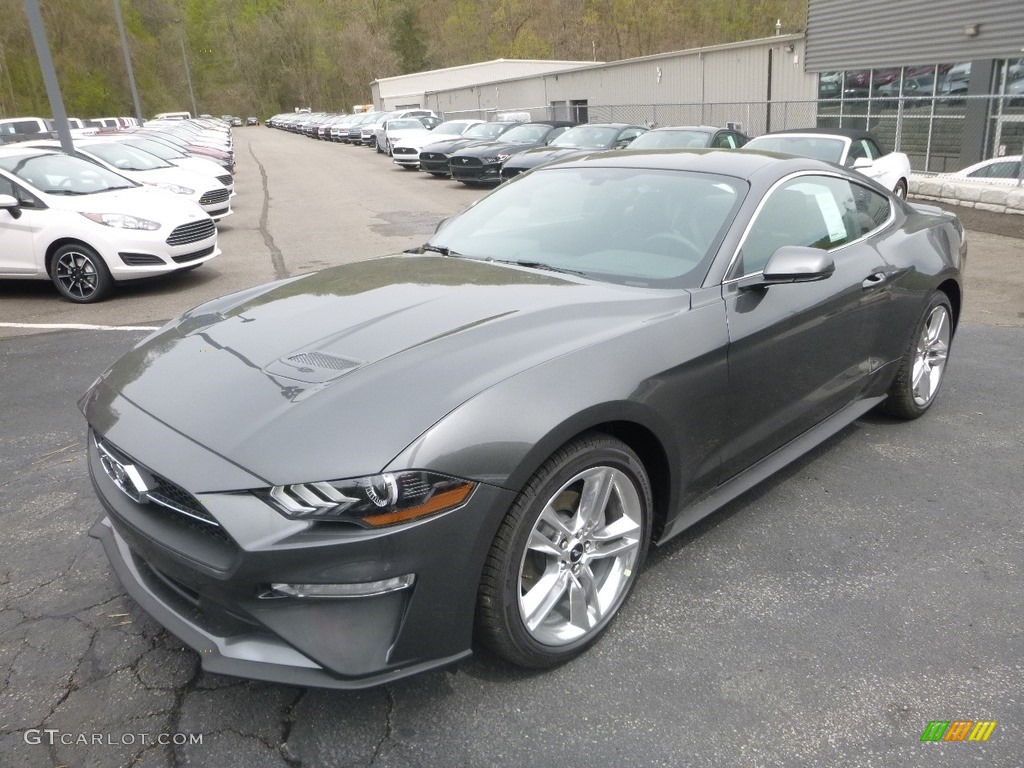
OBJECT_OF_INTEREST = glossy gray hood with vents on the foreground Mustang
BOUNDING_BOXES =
[84,256,688,490]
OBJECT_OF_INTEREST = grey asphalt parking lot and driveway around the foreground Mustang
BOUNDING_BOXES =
[0,127,1024,768]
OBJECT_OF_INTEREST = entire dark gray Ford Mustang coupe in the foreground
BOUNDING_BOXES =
[81,151,966,688]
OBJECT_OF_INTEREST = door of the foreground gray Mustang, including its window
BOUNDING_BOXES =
[722,174,893,478]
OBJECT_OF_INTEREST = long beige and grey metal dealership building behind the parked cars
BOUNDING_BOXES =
[372,0,1024,172]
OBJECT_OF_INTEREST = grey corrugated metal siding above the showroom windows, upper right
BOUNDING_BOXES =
[807,0,1024,72]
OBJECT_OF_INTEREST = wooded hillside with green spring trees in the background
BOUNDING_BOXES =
[0,0,807,118]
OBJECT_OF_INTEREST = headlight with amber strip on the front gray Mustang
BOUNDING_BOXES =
[257,470,476,528]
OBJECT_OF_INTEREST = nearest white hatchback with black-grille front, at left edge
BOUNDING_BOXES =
[0,144,220,303]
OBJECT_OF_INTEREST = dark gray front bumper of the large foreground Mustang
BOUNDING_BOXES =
[83,421,512,688]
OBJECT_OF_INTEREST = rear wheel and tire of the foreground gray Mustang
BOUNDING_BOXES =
[882,291,953,419]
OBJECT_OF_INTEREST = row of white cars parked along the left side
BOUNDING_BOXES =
[0,120,234,303]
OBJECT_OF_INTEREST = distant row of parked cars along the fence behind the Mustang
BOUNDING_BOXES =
[266,110,910,199]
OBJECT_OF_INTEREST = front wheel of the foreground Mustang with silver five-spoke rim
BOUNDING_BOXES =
[477,433,653,669]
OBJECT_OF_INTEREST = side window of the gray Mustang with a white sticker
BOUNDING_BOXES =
[730,176,889,278]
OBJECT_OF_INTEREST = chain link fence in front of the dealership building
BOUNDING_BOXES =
[444,95,1024,173]
